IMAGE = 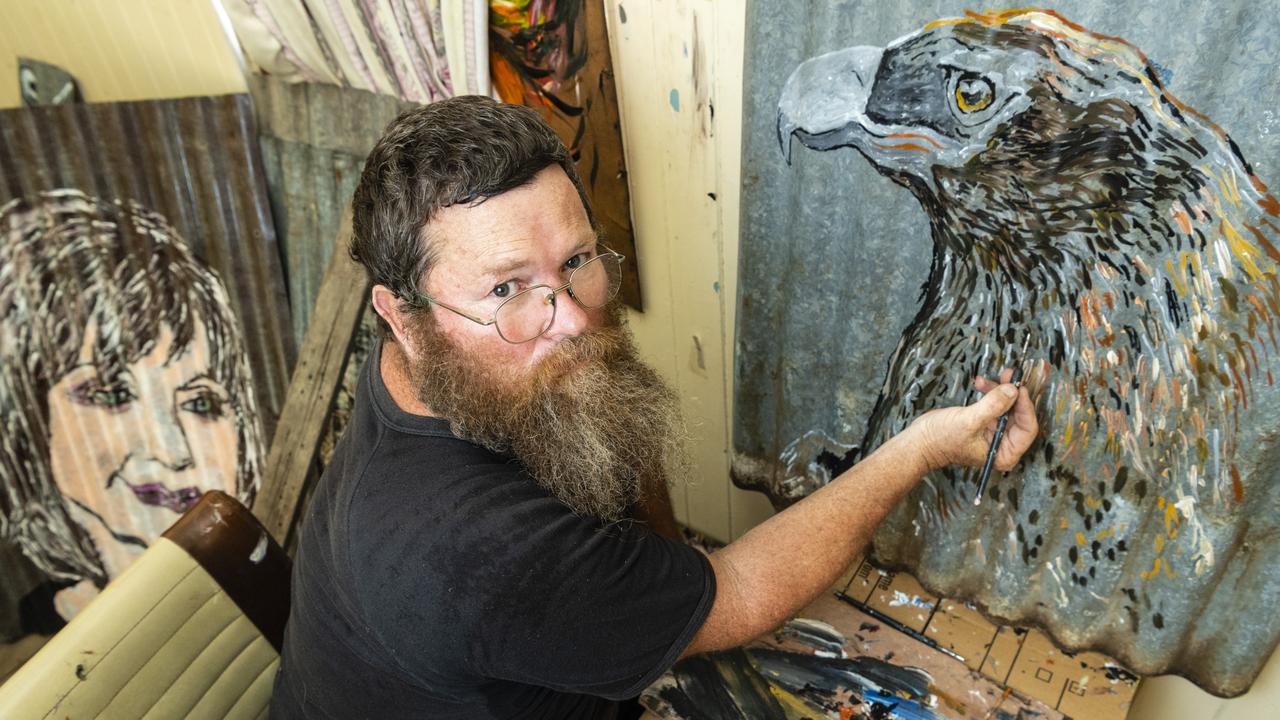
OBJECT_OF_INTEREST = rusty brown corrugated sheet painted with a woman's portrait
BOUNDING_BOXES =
[0,95,294,632]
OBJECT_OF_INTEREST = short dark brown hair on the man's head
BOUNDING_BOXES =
[349,95,595,336]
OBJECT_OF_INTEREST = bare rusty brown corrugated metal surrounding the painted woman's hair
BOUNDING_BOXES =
[0,95,294,430]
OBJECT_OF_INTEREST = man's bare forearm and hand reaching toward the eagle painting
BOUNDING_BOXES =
[681,377,1037,657]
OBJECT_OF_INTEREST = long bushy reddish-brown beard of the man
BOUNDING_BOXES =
[406,299,684,523]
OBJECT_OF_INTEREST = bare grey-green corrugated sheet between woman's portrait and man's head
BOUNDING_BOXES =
[250,76,415,346]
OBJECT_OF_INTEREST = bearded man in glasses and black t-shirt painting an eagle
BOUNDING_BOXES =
[271,96,1037,720]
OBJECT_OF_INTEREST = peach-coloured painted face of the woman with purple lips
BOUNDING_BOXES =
[49,313,238,578]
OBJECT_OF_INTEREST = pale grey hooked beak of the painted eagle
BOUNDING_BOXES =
[778,46,884,155]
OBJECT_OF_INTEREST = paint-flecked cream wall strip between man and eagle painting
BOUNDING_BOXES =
[604,0,772,541]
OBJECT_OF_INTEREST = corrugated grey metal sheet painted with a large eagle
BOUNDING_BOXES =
[733,1,1280,696]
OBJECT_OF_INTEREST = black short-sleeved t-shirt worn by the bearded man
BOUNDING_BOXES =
[271,338,716,720]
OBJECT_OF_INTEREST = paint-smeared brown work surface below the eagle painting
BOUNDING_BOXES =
[641,562,1137,720]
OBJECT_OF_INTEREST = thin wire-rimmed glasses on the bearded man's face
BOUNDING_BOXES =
[408,247,626,345]
